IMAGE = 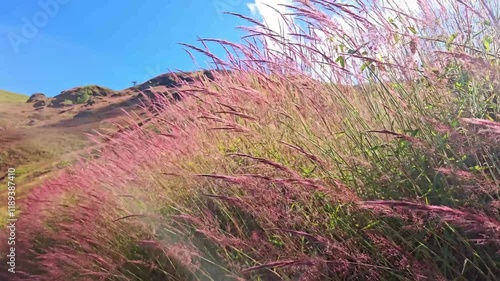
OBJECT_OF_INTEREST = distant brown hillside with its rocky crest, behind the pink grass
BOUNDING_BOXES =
[0,70,213,202]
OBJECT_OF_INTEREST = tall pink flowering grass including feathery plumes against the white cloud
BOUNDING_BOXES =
[0,0,500,280]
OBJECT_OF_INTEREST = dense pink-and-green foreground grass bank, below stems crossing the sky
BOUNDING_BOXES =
[0,0,500,281]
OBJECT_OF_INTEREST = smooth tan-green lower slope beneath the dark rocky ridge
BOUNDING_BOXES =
[0,92,144,227]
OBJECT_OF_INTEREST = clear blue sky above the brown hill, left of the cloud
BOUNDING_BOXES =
[0,0,251,96]
